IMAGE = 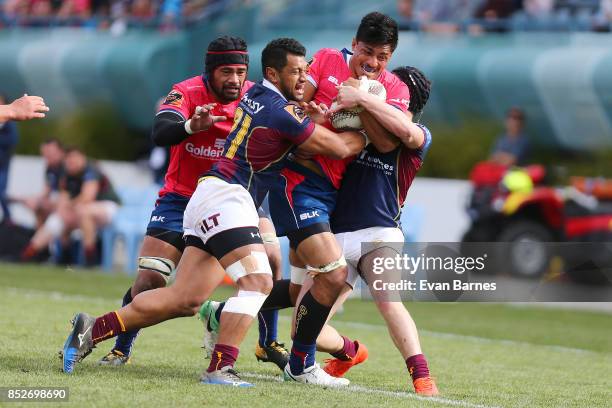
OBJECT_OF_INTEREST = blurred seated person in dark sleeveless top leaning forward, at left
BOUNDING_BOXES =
[21,148,119,265]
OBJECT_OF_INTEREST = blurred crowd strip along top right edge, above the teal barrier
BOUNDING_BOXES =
[397,0,612,33]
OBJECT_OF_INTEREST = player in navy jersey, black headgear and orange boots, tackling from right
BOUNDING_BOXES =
[317,67,438,396]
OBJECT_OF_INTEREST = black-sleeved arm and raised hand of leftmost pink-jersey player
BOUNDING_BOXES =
[151,103,227,146]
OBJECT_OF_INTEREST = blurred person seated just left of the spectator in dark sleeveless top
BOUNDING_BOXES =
[16,138,64,228]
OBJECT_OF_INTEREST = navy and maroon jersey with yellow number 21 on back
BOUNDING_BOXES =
[206,80,315,206]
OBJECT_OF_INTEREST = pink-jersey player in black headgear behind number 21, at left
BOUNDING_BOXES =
[94,37,288,366]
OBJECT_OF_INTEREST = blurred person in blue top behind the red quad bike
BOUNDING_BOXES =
[489,108,529,167]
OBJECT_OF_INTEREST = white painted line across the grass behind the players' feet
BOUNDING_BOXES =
[2,287,601,354]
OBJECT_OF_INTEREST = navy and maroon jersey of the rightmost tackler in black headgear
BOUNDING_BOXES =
[331,125,431,233]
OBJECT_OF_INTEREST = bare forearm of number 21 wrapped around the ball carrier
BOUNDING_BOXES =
[300,124,365,159]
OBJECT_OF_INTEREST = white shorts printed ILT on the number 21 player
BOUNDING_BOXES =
[183,177,259,244]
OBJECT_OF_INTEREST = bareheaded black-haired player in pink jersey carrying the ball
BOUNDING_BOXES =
[202,12,410,382]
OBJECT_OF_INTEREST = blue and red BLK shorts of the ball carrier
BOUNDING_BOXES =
[268,166,338,237]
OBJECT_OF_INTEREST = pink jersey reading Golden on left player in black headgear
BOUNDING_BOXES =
[158,76,254,197]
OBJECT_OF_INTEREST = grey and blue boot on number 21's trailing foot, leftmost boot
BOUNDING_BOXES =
[62,313,96,374]
